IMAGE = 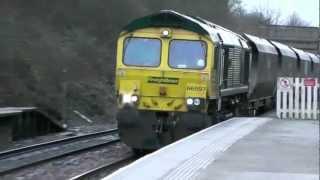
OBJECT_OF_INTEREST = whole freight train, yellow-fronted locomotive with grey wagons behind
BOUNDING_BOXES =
[115,10,320,149]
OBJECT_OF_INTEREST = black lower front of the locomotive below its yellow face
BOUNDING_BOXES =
[117,106,213,150]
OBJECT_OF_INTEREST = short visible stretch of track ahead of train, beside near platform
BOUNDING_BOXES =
[69,154,137,180]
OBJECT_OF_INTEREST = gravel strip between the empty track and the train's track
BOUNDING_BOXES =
[0,143,132,180]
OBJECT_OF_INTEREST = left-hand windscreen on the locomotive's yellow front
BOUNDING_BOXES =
[123,37,161,67]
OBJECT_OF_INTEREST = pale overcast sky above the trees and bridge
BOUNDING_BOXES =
[242,0,319,27]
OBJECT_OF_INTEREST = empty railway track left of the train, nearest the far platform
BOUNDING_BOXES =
[0,129,120,175]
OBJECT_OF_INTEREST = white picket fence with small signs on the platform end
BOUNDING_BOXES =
[277,77,319,119]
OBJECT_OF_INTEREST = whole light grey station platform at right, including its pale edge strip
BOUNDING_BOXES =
[104,117,319,180]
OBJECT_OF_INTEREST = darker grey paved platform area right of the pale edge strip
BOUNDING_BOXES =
[197,120,319,180]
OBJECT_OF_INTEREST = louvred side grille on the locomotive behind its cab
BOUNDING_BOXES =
[227,48,241,87]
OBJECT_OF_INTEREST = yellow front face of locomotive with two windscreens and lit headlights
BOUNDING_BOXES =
[116,28,215,112]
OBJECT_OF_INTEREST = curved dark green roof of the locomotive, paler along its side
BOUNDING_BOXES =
[124,10,249,48]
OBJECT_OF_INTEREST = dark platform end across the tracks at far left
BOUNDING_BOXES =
[0,107,67,143]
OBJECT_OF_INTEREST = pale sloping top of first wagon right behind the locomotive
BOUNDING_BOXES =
[244,34,278,54]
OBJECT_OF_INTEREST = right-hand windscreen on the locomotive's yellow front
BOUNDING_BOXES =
[169,40,207,69]
